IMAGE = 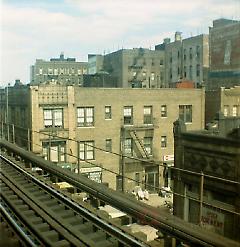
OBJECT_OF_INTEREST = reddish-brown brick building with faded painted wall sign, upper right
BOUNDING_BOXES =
[207,19,240,90]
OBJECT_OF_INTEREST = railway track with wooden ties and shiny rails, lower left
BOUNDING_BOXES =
[0,155,148,247]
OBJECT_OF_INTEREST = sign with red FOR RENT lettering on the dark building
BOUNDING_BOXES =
[201,207,224,235]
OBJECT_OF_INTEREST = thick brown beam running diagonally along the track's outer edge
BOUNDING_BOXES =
[0,139,240,247]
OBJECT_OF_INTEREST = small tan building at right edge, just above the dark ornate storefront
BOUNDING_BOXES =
[205,86,240,124]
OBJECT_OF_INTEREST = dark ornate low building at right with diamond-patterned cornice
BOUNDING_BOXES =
[173,116,240,241]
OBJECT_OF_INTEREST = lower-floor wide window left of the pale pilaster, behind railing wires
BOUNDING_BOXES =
[42,141,66,162]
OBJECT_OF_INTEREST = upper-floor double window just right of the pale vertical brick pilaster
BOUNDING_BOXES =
[77,107,94,127]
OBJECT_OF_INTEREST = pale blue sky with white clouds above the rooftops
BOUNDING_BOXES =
[0,0,240,86]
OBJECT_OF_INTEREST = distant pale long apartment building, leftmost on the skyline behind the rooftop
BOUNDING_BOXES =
[30,53,88,85]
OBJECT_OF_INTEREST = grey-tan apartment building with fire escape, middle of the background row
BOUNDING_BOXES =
[103,48,164,88]
